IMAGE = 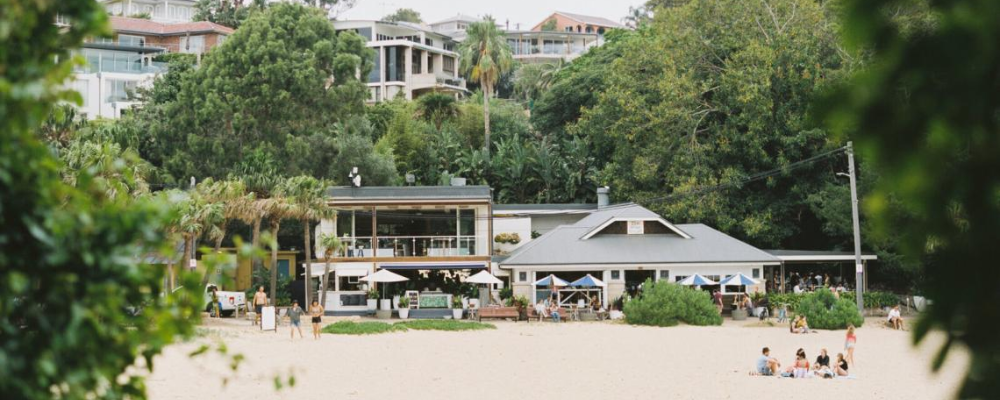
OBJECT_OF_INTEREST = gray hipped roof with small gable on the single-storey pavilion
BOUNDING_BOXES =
[501,205,780,266]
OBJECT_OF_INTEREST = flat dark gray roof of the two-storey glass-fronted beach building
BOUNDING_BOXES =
[326,186,491,201]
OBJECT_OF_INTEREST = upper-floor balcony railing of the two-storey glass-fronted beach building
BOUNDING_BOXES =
[335,236,482,257]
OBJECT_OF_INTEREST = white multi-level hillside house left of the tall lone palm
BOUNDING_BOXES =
[333,20,467,103]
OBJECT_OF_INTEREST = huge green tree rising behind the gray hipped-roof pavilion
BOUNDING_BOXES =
[571,0,842,246]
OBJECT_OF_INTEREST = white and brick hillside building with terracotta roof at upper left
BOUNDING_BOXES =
[72,16,233,119]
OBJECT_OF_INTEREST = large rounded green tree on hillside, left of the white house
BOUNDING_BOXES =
[147,3,373,185]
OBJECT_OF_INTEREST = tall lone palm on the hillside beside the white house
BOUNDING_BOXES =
[459,17,514,155]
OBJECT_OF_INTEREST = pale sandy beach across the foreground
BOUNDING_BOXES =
[148,317,968,400]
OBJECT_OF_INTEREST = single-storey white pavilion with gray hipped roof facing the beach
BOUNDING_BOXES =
[499,204,781,304]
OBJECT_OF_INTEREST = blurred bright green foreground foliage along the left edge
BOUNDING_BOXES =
[0,0,199,399]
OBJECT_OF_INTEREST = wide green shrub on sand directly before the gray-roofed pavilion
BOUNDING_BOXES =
[624,280,722,326]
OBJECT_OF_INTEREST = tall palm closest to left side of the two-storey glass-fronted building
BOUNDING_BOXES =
[278,175,336,305]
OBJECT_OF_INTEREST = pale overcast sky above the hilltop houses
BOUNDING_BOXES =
[338,0,645,29]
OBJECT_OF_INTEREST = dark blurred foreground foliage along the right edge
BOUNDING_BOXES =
[821,0,1000,398]
